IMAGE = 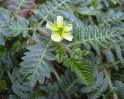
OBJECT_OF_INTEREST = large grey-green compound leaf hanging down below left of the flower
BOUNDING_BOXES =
[20,38,55,87]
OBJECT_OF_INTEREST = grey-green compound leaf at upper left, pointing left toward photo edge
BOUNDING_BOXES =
[2,18,31,37]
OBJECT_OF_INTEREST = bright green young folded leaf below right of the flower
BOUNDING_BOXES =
[64,58,93,85]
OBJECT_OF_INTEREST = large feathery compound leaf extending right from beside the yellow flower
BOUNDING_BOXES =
[79,25,122,51]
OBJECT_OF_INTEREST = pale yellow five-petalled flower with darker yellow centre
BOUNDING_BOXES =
[46,16,73,42]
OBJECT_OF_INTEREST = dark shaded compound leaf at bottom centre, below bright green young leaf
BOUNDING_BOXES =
[40,69,82,99]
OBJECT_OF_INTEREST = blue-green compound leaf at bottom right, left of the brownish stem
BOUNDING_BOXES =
[81,69,109,99]
